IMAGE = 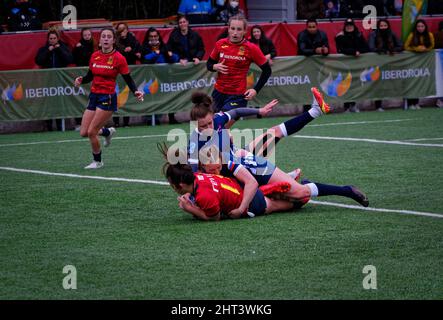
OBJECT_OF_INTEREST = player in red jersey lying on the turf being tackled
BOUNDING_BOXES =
[158,144,294,220]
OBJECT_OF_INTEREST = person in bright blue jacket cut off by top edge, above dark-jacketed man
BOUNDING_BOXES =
[177,0,215,24]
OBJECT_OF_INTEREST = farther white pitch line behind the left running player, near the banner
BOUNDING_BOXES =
[0,119,420,148]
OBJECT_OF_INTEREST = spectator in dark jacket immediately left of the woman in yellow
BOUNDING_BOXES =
[368,19,403,111]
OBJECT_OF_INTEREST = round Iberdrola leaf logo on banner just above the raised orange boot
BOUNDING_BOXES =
[318,61,352,97]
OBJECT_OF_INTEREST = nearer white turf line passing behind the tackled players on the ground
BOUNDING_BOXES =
[0,167,443,218]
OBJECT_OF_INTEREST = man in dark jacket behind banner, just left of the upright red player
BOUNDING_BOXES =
[168,15,205,65]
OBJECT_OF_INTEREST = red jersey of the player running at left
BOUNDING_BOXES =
[89,50,129,94]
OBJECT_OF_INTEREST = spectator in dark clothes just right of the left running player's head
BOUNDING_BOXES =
[112,22,142,127]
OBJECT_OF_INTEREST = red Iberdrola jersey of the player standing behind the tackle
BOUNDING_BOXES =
[210,38,267,95]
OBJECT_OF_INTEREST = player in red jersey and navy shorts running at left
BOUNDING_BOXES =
[74,28,143,169]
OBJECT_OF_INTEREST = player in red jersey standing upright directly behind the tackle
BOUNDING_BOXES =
[206,16,272,112]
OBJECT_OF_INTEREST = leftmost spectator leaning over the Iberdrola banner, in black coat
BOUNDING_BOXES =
[35,30,72,131]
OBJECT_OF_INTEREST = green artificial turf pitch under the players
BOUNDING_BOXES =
[0,108,443,300]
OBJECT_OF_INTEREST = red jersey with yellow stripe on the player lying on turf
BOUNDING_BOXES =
[194,173,243,217]
